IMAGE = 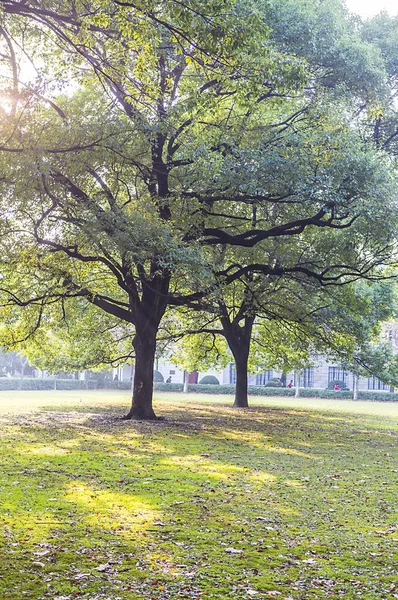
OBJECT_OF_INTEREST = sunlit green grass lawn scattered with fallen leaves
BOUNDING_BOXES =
[0,391,398,600]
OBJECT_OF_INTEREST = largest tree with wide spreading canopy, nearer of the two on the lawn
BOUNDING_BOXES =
[0,0,396,419]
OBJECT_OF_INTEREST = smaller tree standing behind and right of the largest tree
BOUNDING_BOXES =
[170,277,396,408]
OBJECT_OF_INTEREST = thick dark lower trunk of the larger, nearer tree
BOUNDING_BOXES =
[124,320,157,420]
